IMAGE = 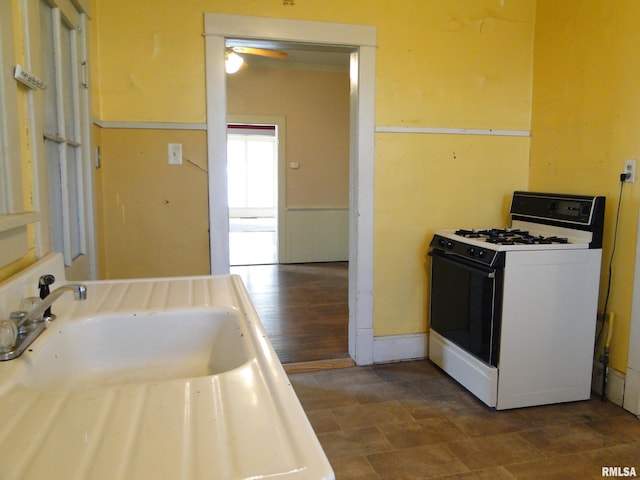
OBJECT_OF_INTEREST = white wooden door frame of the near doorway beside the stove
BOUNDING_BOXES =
[204,13,376,365]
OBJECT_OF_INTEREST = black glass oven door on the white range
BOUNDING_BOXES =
[429,250,503,367]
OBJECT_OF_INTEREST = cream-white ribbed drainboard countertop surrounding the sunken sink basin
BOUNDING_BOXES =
[0,266,334,480]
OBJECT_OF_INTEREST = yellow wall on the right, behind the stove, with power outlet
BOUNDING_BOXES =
[530,0,640,372]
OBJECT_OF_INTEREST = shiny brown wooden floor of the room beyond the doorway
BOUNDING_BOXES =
[231,262,349,364]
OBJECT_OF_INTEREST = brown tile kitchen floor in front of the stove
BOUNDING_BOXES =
[289,360,640,480]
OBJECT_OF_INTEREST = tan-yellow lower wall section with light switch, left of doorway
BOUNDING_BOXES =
[96,128,210,278]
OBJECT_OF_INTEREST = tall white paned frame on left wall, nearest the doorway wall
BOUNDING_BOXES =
[39,0,89,265]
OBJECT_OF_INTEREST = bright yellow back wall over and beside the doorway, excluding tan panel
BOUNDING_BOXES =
[94,0,535,335]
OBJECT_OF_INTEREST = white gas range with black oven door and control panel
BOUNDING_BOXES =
[427,192,605,409]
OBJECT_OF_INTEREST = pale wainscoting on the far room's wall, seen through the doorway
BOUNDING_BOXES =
[279,208,349,263]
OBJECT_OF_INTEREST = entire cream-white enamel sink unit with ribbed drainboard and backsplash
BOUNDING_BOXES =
[0,262,335,480]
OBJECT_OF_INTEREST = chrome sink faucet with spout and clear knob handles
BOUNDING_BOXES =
[0,283,87,360]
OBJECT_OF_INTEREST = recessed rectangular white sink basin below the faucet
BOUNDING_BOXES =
[20,308,250,390]
